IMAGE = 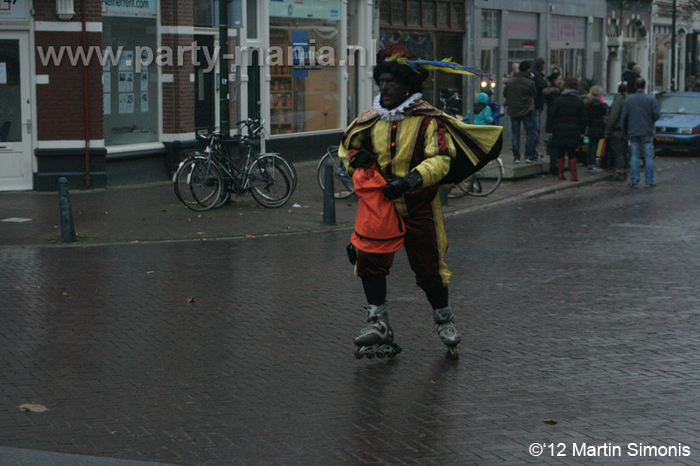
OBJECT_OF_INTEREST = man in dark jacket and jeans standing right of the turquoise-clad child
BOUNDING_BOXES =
[504,61,537,163]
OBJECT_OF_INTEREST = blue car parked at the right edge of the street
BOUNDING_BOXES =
[654,92,700,152]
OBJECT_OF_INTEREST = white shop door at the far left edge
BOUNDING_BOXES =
[0,32,32,191]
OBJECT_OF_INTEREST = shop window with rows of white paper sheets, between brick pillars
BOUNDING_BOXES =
[102,15,159,146]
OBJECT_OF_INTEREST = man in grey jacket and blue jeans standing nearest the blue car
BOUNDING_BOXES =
[622,78,661,187]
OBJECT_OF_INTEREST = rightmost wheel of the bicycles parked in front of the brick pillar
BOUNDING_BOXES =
[248,155,295,208]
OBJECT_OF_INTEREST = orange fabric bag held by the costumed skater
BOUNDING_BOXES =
[350,166,406,254]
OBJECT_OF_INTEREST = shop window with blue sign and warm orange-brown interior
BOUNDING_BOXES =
[267,0,345,134]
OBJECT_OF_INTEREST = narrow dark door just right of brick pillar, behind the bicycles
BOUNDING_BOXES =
[194,36,217,131]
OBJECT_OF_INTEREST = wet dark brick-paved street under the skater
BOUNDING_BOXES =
[0,157,700,465]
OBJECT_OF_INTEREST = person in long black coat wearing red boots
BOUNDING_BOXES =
[549,78,588,181]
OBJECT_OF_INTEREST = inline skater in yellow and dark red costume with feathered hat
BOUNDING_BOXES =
[339,51,503,358]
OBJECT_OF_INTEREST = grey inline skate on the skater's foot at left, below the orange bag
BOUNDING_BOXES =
[353,303,402,359]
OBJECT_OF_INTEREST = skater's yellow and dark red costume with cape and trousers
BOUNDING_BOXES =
[339,94,502,293]
